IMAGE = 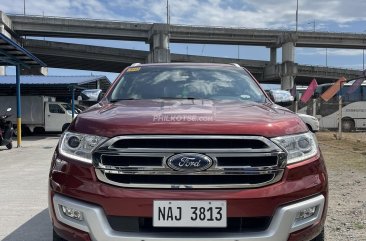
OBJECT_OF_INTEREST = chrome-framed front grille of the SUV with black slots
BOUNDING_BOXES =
[93,135,286,189]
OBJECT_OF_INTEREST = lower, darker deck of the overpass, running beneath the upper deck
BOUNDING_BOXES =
[23,39,362,84]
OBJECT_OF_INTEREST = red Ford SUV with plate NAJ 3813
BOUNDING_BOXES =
[49,63,328,241]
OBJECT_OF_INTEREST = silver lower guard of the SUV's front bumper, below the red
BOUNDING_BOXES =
[53,194,325,241]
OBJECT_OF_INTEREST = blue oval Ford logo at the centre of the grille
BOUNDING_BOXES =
[166,153,213,172]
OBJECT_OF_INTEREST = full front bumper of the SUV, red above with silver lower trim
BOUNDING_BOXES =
[49,148,328,241]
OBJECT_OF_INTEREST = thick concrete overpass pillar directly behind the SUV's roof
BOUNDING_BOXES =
[147,23,170,63]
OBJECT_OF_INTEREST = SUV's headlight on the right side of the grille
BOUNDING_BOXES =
[271,132,318,164]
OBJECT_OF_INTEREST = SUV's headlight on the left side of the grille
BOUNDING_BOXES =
[60,132,107,163]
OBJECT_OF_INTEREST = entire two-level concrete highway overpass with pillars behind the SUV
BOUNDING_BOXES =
[0,11,366,89]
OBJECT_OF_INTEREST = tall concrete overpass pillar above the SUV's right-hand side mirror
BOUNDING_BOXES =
[281,42,297,90]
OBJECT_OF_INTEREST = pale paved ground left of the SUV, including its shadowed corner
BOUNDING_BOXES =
[0,135,59,241]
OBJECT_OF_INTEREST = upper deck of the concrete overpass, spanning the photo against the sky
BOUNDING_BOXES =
[5,15,366,49]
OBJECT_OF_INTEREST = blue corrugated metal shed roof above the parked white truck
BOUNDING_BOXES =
[0,75,111,85]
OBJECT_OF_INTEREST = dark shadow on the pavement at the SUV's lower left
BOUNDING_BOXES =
[2,209,52,241]
